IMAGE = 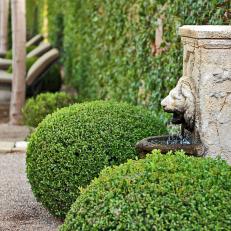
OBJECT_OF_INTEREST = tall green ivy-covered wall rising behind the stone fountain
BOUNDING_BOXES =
[26,0,231,107]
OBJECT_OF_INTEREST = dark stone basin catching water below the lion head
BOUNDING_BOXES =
[136,135,204,158]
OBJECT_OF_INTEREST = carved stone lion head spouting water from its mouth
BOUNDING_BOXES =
[161,76,196,130]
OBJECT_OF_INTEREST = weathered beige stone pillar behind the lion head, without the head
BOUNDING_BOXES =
[180,26,231,164]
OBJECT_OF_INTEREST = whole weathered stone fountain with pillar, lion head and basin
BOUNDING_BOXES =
[137,26,231,164]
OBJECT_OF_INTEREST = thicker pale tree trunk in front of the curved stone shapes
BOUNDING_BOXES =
[10,0,26,124]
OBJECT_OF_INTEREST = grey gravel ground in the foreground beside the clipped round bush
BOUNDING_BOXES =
[0,154,60,231]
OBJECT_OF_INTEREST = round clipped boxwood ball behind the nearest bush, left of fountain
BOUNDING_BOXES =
[26,101,166,217]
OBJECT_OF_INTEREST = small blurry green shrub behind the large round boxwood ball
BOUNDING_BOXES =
[22,92,74,127]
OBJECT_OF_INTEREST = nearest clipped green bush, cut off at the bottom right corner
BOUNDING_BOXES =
[60,151,231,231]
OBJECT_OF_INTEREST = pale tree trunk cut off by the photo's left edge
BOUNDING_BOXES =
[0,0,9,55]
